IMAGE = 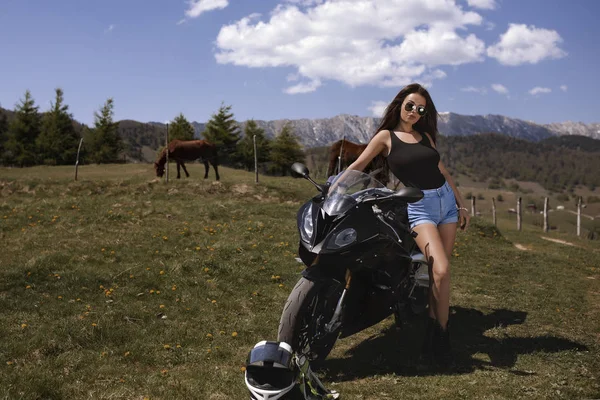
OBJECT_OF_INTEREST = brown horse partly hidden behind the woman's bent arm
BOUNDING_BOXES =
[327,139,389,186]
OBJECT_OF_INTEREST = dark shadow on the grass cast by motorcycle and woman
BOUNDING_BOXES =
[321,307,587,382]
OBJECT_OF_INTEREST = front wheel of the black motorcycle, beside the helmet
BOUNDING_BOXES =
[277,278,343,365]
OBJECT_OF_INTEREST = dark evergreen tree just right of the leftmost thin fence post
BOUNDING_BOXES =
[85,98,123,164]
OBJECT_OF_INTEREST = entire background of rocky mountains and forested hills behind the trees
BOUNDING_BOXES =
[0,104,600,191]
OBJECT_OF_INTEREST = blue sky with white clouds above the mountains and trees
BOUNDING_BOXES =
[0,0,600,124]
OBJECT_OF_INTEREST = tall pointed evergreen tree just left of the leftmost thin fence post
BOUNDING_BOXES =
[37,88,79,165]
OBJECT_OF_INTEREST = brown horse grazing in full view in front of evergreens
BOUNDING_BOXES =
[154,140,219,180]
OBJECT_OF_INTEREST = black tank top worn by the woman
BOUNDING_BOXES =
[387,131,446,190]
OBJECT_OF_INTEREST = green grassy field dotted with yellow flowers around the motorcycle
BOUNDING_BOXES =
[0,164,600,400]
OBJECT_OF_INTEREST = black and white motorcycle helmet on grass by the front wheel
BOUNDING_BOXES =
[245,340,297,400]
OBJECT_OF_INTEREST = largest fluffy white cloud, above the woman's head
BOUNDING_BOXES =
[215,0,485,93]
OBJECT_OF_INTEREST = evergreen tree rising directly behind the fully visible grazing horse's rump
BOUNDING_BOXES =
[202,104,240,165]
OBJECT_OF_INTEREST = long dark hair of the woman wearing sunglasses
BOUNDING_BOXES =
[373,83,438,143]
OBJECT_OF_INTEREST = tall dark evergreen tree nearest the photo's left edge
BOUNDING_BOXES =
[5,90,41,167]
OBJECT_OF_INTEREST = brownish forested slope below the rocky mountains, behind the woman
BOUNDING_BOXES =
[306,133,600,192]
